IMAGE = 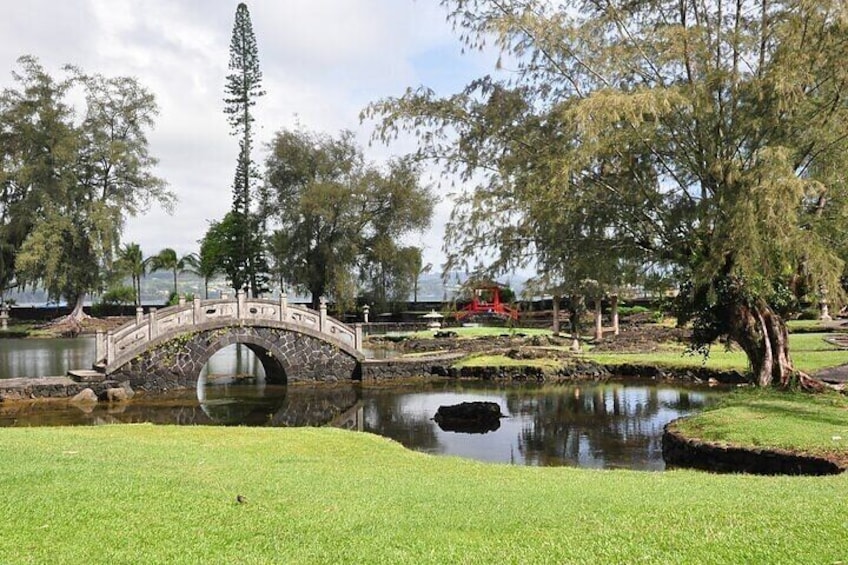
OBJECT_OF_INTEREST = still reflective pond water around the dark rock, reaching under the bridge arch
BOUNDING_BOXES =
[0,346,721,470]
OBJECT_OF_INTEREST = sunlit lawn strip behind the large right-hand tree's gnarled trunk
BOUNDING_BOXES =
[584,333,848,373]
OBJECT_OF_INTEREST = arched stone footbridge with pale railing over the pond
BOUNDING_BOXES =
[95,292,364,392]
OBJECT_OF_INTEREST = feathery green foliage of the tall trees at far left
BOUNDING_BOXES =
[0,57,173,318]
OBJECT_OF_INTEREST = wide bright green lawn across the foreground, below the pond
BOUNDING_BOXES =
[0,425,848,563]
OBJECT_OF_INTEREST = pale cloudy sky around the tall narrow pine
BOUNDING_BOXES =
[0,0,496,265]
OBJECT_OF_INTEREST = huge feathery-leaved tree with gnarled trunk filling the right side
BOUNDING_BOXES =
[366,0,848,386]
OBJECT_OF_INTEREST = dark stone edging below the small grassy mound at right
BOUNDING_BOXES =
[662,420,845,475]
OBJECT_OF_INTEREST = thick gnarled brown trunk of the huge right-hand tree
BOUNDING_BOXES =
[729,300,825,390]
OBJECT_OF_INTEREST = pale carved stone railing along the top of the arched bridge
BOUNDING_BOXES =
[95,292,362,365]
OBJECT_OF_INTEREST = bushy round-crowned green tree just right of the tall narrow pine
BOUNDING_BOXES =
[263,126,433,307]
